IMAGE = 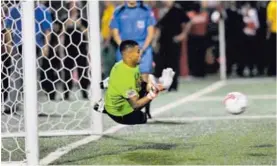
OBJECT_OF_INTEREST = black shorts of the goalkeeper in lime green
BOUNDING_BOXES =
[105,109,147,125]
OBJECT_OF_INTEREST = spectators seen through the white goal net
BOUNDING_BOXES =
[1,1,89,113]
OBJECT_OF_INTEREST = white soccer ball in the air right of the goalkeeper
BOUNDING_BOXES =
[223,92,247,115]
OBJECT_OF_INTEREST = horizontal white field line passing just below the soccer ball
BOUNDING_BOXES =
[151,115,277,122]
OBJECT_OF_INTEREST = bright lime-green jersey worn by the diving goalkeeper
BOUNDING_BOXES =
[105,61,141,116]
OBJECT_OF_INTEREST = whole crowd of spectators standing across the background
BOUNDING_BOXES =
[1,1,276,113]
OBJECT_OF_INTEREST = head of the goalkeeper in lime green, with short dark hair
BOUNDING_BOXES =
[119,40,141,67]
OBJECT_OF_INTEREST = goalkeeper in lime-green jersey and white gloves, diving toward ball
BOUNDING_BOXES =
[94,40,175,125]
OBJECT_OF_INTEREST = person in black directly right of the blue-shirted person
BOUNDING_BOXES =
[154,1,189,91]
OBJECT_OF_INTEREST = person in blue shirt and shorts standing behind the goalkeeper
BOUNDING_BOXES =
[110,1,156,118]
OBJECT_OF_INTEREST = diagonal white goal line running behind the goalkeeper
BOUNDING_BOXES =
[40,81,226,165]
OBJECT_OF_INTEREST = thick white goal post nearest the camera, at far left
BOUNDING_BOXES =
[21,1,39,165]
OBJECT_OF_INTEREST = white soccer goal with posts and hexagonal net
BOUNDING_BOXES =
[1,1,103,165]
